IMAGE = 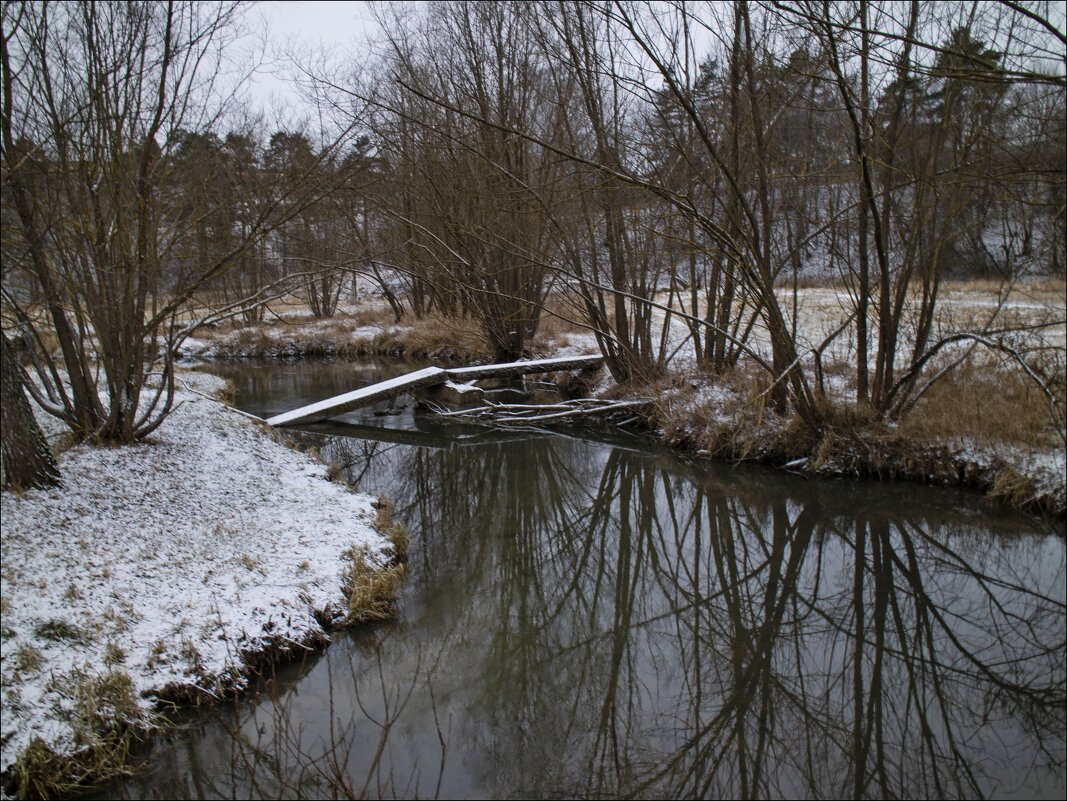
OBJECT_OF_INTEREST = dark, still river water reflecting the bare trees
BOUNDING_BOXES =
[96,363,1067,799]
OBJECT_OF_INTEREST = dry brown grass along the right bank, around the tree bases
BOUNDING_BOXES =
[640,361,1067,517]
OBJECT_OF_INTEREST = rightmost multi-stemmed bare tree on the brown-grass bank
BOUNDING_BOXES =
[775,0,1063,417]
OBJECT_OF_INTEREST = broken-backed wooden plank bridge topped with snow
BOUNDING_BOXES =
[267,355,604,426]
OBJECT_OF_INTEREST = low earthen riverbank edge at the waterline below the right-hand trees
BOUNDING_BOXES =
[637,366,1067,520]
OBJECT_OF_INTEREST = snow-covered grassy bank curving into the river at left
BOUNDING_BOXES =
[0,373,388,793]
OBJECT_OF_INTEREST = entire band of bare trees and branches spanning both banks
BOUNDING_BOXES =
[2,0,1067,467]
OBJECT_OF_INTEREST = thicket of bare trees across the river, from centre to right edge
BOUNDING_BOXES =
[349,2,1067,429]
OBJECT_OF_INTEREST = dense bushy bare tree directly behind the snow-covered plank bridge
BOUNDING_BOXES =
[377,3,560,359]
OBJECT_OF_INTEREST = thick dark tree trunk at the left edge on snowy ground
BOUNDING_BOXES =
[0,331,60,487]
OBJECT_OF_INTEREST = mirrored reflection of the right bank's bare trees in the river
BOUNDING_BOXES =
[379,442,1064,798]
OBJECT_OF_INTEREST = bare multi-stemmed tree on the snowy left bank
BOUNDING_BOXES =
[2,2,358,443]
